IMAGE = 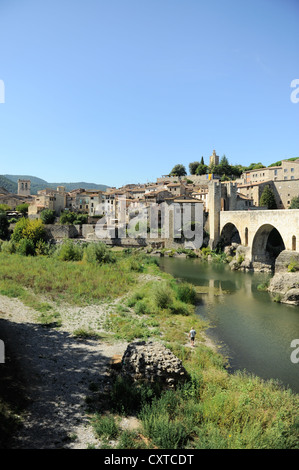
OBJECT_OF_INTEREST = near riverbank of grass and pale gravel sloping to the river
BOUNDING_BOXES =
[0,246,299,448]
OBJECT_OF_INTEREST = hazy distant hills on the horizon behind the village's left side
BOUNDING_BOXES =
[0,175,109,194]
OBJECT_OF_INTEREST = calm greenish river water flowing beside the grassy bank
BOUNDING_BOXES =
[159,257,299,393]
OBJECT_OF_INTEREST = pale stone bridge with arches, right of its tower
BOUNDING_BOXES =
[219,209,299,263]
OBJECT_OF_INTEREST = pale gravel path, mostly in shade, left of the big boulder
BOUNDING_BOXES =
[0,296,127,449]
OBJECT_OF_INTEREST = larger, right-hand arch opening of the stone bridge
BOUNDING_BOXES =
[251,223,286,266]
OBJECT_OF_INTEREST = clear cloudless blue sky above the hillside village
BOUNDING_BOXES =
[0,0,299,187]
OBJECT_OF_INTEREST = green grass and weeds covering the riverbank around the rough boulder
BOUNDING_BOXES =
[0,244,299,449]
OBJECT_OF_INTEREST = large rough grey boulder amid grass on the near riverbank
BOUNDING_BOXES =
[121,341,188,388]
